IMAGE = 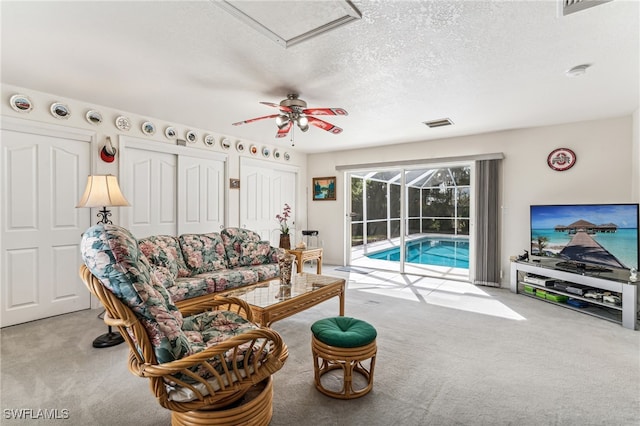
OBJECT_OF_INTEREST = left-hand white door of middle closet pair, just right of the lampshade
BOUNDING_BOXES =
[120,147,178,239]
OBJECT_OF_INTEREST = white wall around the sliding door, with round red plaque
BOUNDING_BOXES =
[308,116,638,286]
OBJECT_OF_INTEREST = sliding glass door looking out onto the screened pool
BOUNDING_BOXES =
[349,164,471,280]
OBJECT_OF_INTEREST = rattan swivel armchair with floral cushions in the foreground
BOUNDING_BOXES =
[80,225,287,425]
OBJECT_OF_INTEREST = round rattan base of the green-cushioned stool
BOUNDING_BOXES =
[311,335,377,399]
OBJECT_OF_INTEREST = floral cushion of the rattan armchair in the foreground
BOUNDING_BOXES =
[81,225,260,374]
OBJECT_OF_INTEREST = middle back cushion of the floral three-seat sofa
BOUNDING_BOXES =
[178,232,228,275]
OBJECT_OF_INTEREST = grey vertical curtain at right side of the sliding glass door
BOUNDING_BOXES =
[472,160,502,287]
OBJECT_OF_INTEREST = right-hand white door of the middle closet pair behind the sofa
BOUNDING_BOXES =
[178,155,224,234]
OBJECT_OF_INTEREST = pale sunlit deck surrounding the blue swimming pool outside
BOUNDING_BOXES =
[351,234,469,282]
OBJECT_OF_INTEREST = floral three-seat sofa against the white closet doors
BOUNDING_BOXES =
[138,228,284,308]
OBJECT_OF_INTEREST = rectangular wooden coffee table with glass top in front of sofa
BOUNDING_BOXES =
[218,273,345,327]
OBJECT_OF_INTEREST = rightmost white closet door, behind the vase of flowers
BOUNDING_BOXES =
[240,158,298,246]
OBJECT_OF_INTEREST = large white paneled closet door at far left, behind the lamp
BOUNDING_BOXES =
[0,119,91,327]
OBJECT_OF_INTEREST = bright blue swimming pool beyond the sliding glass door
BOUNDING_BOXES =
[367,237,469,269]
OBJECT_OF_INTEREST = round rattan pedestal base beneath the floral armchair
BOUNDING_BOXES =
[171,377,273,426]
